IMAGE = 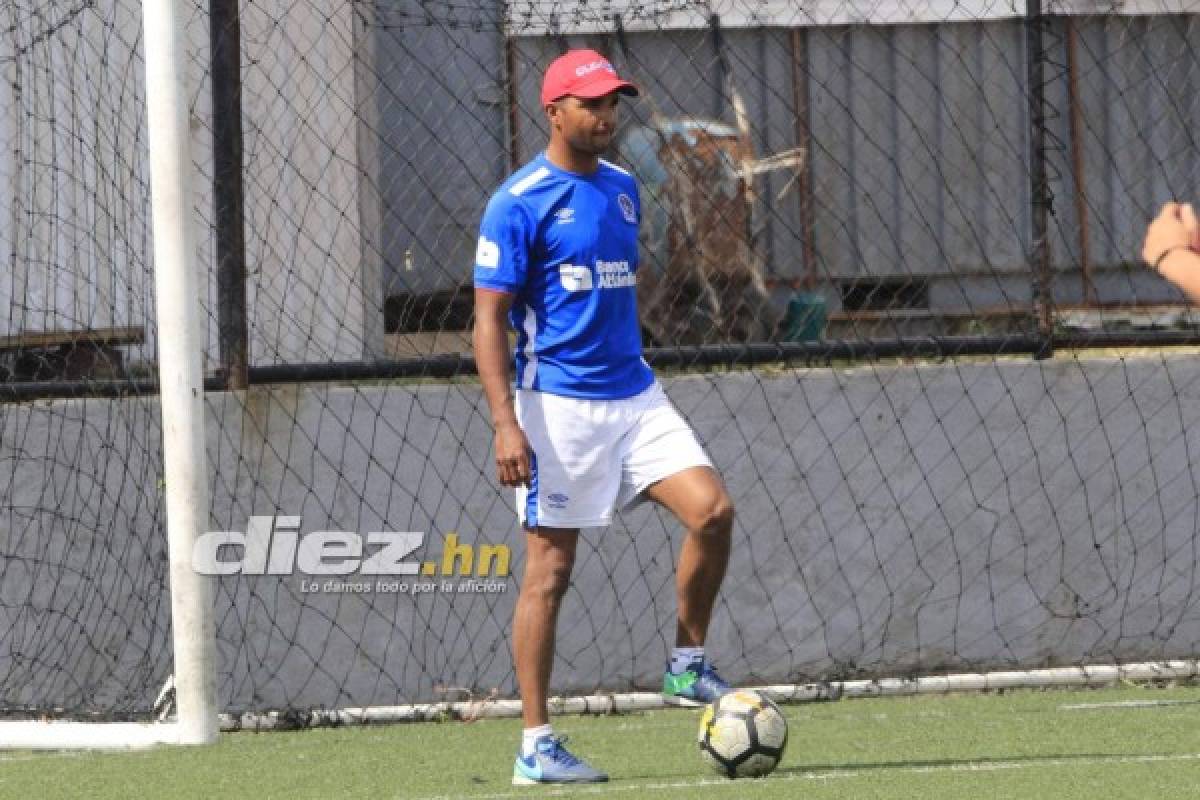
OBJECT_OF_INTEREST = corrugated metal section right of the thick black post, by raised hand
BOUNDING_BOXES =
[1048,16,1200,302]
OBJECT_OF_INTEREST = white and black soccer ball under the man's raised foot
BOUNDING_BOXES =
[696,690,787,777]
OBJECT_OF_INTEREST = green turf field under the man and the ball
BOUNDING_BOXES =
[7,686,1200,800]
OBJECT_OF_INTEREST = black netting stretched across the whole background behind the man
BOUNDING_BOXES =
[0,0,1200,716]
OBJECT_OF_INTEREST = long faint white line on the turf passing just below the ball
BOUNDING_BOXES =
[408,753,1200,800]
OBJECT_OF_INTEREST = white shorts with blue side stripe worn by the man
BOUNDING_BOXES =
[515,381,712,528]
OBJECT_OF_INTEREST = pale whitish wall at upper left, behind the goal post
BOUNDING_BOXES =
[0,0,383,367]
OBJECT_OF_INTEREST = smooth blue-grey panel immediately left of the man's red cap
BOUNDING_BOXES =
[373,0,508,295]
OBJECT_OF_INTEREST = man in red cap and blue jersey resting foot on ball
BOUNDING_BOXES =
[474,50,733,784]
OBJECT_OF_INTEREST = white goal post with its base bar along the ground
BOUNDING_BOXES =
[0,0,218,750]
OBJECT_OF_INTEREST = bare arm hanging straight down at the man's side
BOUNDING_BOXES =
[472,287,530,487]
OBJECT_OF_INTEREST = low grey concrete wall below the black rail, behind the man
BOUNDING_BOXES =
[0,356,1200,709]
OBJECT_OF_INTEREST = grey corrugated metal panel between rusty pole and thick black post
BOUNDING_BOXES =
[809,23,1028,286]
